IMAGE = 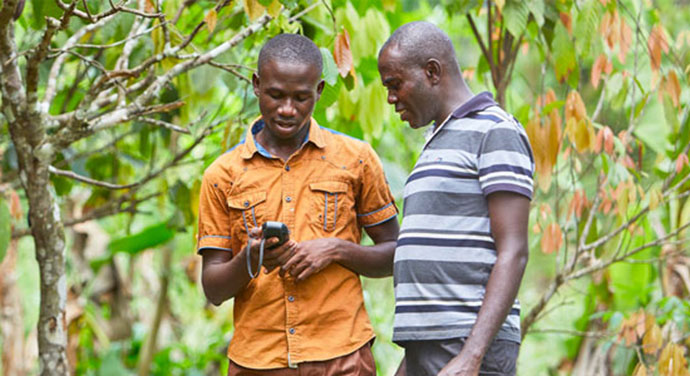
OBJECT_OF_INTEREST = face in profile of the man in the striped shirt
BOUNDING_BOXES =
[379,46,435,129]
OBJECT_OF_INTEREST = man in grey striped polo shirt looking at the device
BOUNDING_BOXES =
[378,22,534,376]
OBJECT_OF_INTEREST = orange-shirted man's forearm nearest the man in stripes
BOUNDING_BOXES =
[335,240,396,278]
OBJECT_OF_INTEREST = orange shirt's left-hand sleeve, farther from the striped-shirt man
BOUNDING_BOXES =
[197,171,232,253]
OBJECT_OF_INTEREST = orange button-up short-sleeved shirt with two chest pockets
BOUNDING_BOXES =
[198,120,397,369]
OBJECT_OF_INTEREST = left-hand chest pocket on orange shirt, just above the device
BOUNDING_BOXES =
[227,191,266,241]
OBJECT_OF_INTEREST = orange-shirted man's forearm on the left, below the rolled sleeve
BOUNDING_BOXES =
[201,250,256,305]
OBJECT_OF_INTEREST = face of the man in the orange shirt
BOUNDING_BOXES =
[252,60,324,140]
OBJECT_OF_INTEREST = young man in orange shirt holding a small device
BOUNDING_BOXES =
[198,34,398,375]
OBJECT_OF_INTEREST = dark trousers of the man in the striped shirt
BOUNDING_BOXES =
[401,338,520,376]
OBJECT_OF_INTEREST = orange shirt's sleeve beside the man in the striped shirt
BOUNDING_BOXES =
[357,145,398,227]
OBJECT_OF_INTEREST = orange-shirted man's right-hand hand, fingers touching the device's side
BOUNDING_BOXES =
[280,238,343,282]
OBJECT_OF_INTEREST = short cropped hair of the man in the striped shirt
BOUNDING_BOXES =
[379,21,459,69]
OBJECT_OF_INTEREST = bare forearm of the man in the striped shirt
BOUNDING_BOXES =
[463,249,527,359]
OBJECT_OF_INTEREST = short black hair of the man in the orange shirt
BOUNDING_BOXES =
[257,34,323,75]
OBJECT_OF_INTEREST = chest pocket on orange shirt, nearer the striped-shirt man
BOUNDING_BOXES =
[309,181,354,232]
